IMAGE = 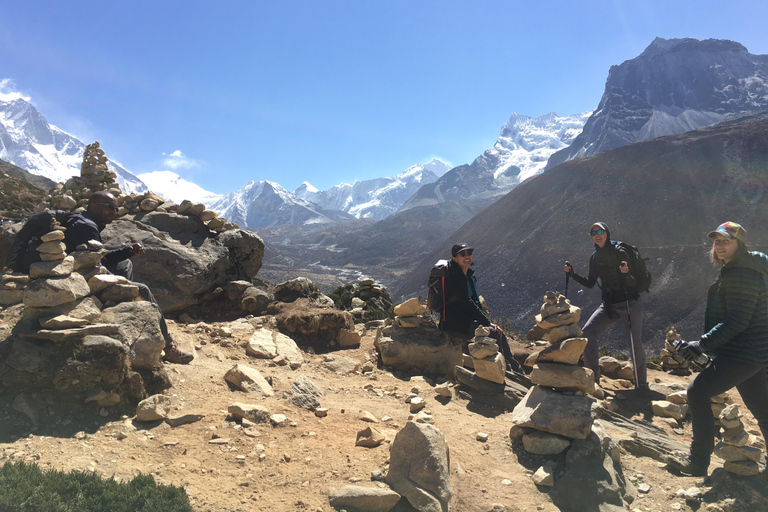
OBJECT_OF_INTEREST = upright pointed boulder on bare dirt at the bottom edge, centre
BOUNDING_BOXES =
[387,421,451,512]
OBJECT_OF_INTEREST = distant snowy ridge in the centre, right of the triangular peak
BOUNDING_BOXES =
[293,159,450,220]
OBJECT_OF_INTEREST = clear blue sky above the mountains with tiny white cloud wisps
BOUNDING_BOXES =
[0,0,768,193]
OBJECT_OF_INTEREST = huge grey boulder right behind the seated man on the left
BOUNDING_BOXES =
[102,212,264,312]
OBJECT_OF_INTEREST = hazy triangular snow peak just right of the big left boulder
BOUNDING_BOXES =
[209,181,353,229]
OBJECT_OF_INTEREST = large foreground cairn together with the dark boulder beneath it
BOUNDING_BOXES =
[509,292,635,510]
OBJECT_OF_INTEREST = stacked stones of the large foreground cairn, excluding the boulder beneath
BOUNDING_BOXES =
[510,292,599,462]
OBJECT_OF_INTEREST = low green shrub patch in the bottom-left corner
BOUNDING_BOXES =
[0,462,192,512]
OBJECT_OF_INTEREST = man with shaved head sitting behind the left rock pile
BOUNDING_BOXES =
[64,191,194,364]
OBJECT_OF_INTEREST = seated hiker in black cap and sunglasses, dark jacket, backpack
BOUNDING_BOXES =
[440,244,524,373]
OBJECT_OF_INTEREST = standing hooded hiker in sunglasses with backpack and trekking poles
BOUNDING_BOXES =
[565,222,650,389]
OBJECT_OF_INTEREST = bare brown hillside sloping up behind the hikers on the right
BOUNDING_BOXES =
[390,110,768,350]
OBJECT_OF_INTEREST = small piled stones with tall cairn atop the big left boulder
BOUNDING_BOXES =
[41,141,238,233]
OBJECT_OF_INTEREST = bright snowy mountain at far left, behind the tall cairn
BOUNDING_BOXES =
[0,98,147,193]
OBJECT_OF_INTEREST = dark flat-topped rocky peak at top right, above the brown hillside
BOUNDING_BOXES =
[547,38,768,168]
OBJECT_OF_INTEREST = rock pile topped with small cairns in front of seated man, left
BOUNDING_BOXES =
[6,232,164,407]
